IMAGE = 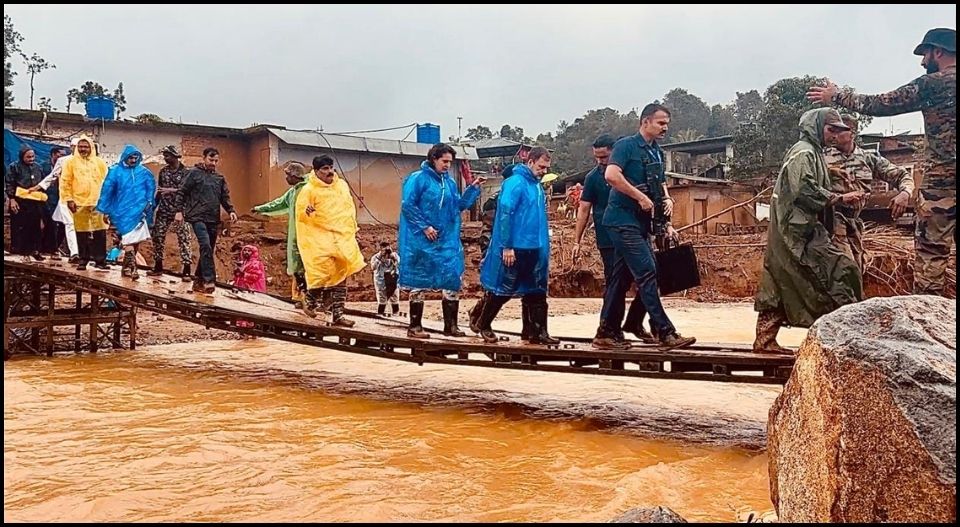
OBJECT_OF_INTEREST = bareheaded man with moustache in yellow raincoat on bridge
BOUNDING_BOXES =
[297,155,366,328]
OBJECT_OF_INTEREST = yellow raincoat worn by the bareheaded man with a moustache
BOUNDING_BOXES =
[296,173,366,289]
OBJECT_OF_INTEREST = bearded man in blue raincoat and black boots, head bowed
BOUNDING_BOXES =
[476,147,560,345]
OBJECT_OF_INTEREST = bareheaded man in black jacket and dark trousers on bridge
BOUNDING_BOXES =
[174,146,237,294]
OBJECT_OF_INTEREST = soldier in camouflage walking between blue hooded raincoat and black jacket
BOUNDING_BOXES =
[147,145,193,282]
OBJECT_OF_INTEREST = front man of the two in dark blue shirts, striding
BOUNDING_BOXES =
[593,104,696,350]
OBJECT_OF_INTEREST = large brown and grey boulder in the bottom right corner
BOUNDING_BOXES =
[767,296,957,523]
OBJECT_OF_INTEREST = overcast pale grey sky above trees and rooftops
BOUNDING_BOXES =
[4,4,957,139]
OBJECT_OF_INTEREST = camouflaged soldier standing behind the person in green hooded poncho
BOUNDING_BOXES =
[824,114,913,275]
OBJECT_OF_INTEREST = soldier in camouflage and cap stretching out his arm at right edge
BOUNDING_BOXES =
[807,28,957,295]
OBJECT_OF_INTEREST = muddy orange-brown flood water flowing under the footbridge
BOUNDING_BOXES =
[4,305,803,522]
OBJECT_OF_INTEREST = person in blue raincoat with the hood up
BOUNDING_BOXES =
[96,145,157,280]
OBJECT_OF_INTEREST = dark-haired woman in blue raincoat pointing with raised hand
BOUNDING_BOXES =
[399,143,483,339]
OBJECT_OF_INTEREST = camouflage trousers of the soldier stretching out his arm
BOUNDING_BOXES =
[913,189,957,295]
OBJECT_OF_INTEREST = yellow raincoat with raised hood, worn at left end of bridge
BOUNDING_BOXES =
[60,135,107,232]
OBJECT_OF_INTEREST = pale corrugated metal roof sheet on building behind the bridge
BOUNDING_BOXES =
[268,128,480,160]
